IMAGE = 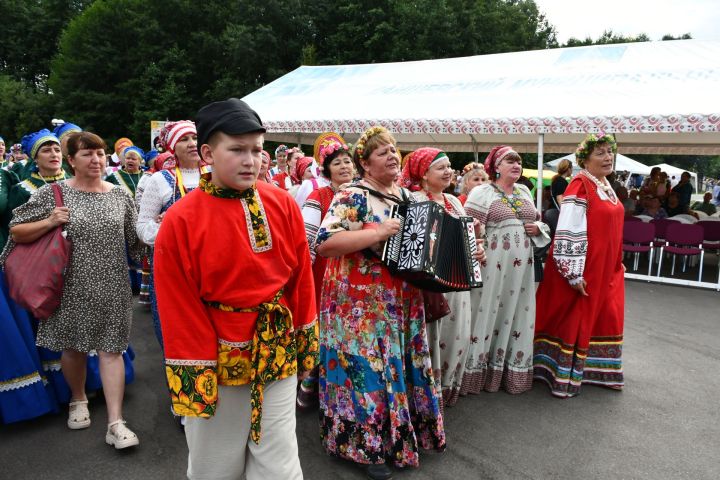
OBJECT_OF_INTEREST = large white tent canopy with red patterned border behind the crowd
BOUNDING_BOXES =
[244,40,720,155]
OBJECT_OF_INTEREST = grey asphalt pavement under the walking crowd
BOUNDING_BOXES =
[0,281,720,480]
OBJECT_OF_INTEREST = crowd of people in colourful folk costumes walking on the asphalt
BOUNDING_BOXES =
[0,103,624,479]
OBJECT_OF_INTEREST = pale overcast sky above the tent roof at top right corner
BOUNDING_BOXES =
[535,0,720,43]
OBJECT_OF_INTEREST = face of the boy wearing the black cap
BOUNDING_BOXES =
[201,132,264,191]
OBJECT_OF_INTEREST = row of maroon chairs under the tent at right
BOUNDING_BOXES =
[623,219,720,283]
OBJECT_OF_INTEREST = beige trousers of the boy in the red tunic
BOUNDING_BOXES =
[185,375,303,480]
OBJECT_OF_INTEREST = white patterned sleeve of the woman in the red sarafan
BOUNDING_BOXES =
[553,178,588,285]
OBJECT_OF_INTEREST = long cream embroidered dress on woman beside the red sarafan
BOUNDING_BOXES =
[461,184,548,394]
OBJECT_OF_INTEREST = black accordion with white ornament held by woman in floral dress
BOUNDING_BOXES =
[382,201,482,292]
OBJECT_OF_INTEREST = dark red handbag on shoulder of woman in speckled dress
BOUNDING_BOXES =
[5,183,72,320]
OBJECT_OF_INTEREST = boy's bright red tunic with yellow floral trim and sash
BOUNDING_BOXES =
[154,180,318,441]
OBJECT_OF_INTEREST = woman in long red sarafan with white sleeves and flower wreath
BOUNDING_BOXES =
[533,134,625,398]
